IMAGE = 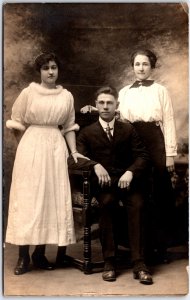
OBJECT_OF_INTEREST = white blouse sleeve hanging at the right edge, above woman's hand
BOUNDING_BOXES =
[160,87,177,156]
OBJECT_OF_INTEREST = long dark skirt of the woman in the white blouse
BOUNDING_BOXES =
[133,122,175,248]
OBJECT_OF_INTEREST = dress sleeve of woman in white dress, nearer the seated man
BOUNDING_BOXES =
[61,92,79,135]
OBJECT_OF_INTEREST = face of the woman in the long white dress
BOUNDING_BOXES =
[40,61,58,88]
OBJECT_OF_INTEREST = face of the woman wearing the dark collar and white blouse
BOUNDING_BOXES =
[133,54,152,80]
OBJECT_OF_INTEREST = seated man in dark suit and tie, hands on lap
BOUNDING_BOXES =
[69,87,153,284]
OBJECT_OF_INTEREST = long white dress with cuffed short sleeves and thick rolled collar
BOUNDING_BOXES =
[6,82,78,246]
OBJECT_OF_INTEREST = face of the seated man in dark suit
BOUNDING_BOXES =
[96,93,119,122]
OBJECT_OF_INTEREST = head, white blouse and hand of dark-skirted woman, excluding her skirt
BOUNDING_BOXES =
[119,50,177,171]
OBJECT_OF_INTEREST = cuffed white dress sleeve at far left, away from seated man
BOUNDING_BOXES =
[6,89,28,131]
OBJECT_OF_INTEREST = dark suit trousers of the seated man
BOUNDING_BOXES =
[93,180,143,261]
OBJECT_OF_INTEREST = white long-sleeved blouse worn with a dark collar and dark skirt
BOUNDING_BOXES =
[118,82,177,156]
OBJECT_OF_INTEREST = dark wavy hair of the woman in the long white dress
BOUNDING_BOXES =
[34,52,61,72]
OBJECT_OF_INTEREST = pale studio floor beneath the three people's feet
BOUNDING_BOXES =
[3,239,189,299]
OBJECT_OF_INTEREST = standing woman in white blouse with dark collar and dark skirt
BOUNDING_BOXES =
[118,50,177,262]
